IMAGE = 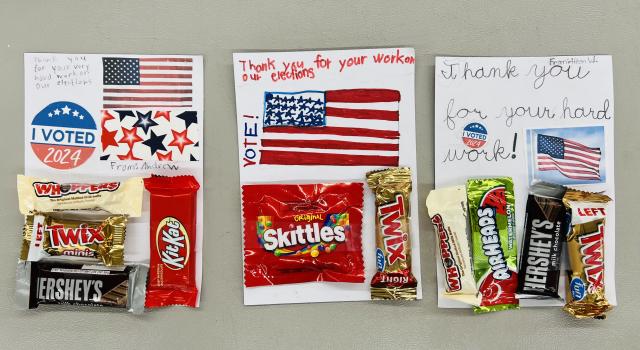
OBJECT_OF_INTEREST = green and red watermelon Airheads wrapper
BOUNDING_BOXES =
[467,177,518,313]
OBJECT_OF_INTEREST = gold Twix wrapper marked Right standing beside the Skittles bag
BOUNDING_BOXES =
[367,168,418,300]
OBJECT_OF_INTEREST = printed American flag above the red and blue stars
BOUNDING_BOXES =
[102,57,193,109]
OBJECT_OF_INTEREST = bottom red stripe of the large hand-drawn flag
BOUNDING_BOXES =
[260,150,398,166]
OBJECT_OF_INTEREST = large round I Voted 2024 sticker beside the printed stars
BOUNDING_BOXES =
[30,101,96,169]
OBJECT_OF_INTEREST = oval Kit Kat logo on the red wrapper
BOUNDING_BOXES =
[156,216,191,270]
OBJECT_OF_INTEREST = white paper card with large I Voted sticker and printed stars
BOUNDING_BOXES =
[24,53,204,304]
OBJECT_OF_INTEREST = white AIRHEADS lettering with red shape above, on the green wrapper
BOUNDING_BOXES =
[478,186,511,280]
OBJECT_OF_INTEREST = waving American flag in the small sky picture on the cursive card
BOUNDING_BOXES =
[536,134,602,180]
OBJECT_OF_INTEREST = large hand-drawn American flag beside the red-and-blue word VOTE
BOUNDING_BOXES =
[260,89,400,166]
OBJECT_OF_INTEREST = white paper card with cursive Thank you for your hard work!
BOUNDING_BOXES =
[434,56,616,307]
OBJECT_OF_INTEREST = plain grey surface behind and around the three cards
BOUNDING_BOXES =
[0,0,640,349]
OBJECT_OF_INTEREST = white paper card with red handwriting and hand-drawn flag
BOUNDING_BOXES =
[233,48,422,305]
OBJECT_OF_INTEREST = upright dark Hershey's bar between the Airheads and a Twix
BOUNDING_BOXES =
[517,182,567,299]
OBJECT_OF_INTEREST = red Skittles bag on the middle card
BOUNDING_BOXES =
[242,183,364,287]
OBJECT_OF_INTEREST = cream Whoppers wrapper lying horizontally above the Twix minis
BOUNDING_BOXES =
[18,175,144,217]
